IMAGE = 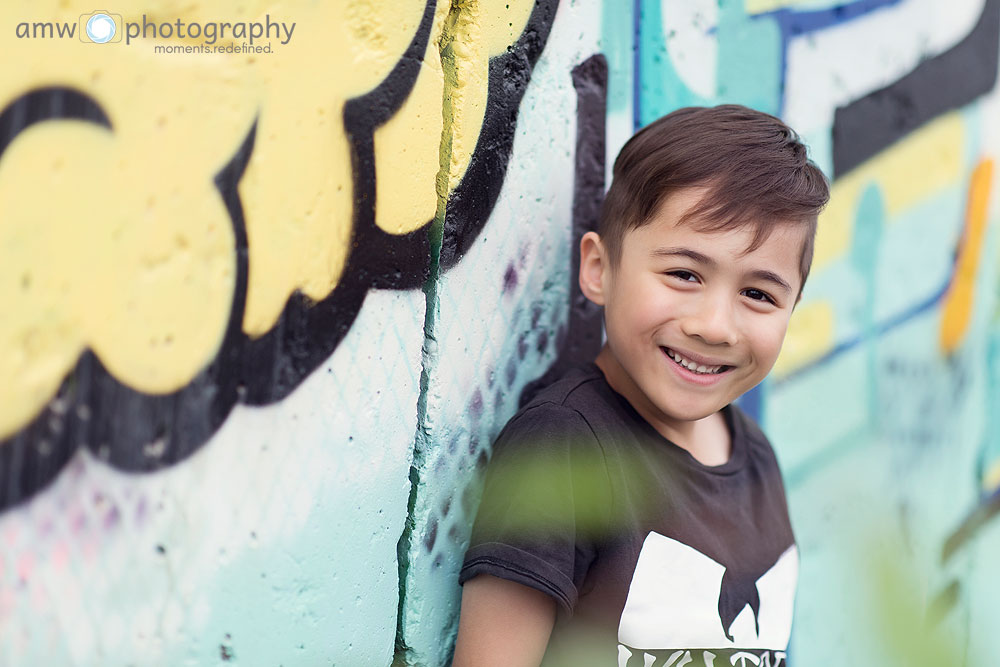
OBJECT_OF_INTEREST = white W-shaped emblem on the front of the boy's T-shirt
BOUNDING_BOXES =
[618,532,798,650]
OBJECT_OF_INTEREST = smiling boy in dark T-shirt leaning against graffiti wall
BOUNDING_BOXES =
[455,105,829,667]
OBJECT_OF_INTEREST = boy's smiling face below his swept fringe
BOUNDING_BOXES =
[585,189,806,429]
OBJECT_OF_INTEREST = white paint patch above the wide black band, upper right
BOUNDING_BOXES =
[783,0,984,147]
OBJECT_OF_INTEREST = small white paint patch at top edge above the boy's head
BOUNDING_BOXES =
[661,0,719,98]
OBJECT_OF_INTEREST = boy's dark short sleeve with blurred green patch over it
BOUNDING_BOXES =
[459,403,611,612]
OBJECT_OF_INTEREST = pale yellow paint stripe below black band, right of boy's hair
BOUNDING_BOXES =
[812,112,965,271]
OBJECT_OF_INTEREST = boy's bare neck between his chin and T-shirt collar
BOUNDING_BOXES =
[594,345,732,466]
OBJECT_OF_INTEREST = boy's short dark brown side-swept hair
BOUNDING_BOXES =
[598,104,830,285]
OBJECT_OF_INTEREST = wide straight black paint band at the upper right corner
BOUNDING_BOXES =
[833,0,1000,177]
